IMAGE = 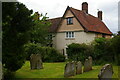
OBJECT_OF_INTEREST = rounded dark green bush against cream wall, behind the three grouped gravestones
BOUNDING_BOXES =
[67,43,93,61]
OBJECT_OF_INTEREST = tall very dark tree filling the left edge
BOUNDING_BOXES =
[2,2,33,72]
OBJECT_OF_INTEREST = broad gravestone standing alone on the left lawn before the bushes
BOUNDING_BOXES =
[30,54,43,69]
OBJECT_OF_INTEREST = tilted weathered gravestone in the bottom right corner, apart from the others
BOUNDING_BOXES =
[98,64,113,80]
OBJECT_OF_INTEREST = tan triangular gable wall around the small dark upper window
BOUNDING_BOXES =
[57,9,84,32]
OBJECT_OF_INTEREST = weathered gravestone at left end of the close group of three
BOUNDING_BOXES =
[64,62,76,77]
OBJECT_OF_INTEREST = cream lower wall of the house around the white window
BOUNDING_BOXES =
[53,31,95,53]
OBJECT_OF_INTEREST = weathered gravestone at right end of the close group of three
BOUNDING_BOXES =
[83,56,92,72]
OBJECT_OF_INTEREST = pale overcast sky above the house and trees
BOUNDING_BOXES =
[18,0,120,33]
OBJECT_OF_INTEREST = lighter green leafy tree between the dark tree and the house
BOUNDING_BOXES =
[31,12,52,46]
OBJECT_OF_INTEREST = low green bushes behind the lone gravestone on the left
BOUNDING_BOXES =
[25,43,65,62]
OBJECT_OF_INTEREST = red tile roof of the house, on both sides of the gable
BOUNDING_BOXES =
[50,6,112,35]
